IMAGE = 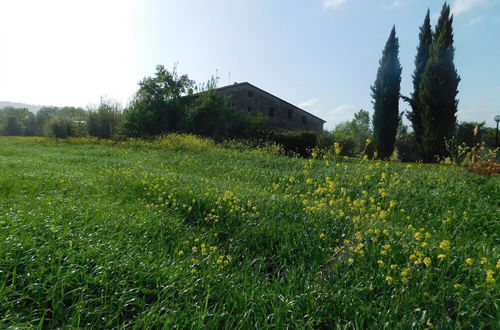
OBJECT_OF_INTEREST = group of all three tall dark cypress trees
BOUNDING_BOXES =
[371,3,460,162]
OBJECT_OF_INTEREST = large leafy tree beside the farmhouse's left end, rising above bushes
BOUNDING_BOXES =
[123,65,194,136]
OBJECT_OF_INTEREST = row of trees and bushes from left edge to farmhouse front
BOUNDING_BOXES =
[0,69,266,141]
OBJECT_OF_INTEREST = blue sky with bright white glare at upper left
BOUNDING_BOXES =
[0,0,500,129]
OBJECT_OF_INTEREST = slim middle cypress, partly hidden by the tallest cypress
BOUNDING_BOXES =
[402,10,432,153]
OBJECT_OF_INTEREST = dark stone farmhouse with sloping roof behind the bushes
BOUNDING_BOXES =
[211,82,325,132]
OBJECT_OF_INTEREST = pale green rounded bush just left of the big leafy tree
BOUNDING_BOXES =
[87,99,123,139]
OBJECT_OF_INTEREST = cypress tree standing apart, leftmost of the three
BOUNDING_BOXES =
[371,27,402,159]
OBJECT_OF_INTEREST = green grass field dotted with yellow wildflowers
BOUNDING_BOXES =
[0,136,500,329]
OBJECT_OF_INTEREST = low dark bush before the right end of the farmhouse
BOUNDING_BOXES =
[270,131,318,157]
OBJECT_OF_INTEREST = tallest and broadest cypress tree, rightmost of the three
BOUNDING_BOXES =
[418,3,460,162]
